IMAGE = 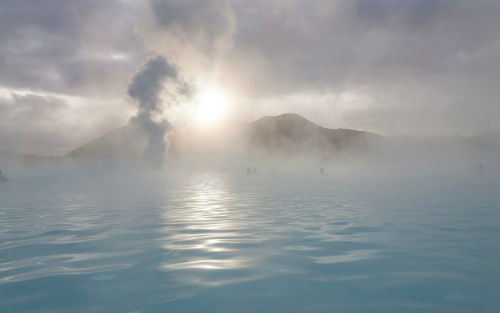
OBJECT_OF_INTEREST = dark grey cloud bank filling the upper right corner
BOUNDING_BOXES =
[232,0,500,92]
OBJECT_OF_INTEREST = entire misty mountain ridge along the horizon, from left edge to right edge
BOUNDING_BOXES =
[0,113,500,165]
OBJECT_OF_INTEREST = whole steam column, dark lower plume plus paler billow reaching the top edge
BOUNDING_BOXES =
[122,0,236,167]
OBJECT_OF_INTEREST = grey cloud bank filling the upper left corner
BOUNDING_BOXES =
[0,0,145,96]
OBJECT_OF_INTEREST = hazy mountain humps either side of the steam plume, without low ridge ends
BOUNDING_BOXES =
[66,113,382,159]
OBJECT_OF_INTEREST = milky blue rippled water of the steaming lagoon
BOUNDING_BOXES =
[0,165,500,312]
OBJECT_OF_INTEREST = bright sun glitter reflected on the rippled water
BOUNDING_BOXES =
[160,174,250,271]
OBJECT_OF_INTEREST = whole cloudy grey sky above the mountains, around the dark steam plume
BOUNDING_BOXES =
[0,0,500,155]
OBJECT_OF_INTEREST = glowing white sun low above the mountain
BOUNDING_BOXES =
[195,87,228,126]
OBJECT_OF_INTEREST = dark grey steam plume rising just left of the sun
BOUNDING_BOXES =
[128,56,191,167]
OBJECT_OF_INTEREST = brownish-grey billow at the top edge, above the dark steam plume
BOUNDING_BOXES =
[138,0,236,76]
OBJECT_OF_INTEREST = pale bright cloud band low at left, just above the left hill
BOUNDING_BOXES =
[0,90,130,155]
